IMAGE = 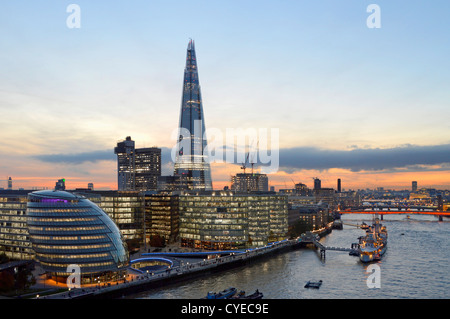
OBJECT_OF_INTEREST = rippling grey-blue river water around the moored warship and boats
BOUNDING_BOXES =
[127,215,450,299]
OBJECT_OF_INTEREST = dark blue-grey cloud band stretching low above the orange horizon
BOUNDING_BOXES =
[34,144,450,175]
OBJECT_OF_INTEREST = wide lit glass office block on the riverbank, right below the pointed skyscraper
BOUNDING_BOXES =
[179,191,288,250]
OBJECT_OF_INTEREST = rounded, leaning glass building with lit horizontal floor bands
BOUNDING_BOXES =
[27,191,129,284]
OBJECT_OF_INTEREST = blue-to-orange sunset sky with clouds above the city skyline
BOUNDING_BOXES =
[0,0,450,189]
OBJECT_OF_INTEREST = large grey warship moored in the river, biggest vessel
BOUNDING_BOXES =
[359,217,387,263]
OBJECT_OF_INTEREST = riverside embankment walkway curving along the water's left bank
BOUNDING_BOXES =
[36,238,301,299]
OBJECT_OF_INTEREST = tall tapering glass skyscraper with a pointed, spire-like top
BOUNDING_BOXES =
[174,40,212,190]
